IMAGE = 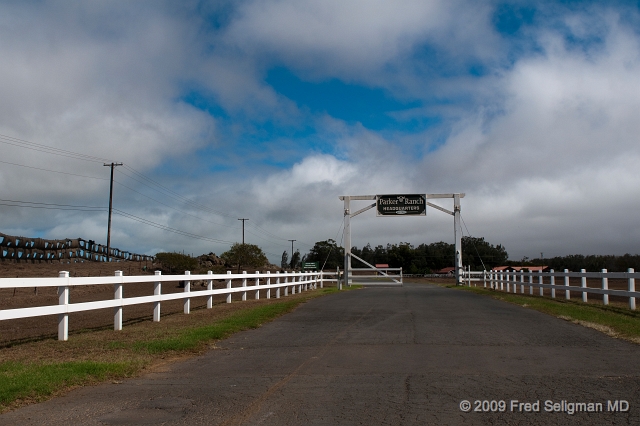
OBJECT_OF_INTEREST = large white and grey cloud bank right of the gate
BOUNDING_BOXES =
[418,12,640,257]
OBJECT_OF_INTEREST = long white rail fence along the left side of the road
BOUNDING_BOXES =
[0,271,333,340]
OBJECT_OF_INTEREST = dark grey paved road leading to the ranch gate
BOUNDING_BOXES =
[0,284,640,425]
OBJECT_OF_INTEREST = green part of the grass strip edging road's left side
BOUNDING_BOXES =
[0,286,348,413]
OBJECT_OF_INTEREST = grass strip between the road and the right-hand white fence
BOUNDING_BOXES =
[447,285,640,343]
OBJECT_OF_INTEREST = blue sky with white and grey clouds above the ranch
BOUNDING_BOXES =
[0,0,640,264]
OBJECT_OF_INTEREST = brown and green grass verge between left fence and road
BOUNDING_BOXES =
[0,287,353,412]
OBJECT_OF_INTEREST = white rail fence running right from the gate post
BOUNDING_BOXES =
[463,268,640,310]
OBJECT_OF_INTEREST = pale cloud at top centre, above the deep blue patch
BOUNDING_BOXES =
[226,0,499,81]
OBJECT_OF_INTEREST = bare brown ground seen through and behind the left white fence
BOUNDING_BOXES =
[0,262,306,348]
